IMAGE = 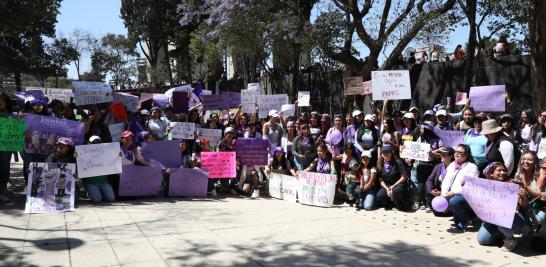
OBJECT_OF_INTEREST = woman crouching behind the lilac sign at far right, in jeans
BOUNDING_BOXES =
[478,162,533,251]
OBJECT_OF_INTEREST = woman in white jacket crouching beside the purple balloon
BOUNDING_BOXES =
[441,145,479,231]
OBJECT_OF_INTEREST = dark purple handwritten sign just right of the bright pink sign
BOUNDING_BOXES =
[234,138,269,166]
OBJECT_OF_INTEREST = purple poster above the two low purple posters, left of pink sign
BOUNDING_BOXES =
[142,140,182,168]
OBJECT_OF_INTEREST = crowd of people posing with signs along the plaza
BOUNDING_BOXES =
[0,89,546,253]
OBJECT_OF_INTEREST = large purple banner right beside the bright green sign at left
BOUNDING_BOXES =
[25,113,84,155]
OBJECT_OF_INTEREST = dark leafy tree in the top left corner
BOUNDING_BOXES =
[0,0,61,91]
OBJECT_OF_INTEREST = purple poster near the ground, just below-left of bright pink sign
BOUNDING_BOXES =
[169,168,209,197]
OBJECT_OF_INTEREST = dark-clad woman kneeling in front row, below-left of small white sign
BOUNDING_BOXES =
[375,145,408,210]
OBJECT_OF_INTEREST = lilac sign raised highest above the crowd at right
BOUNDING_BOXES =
[468,85,506,112]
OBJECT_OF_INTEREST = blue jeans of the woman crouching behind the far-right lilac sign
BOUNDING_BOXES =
[478,212,533,246]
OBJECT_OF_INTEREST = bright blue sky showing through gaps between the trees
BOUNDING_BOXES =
[57,0,468,79]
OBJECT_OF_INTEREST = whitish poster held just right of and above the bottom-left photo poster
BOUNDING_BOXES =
[76,142,121,178]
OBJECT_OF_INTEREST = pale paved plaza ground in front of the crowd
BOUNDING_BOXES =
[0,160,546,267]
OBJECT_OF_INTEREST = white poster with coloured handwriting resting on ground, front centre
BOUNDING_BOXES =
[298,172,337,207]
